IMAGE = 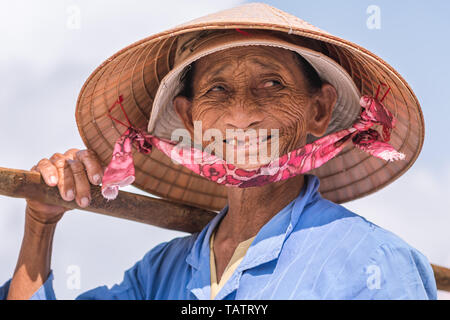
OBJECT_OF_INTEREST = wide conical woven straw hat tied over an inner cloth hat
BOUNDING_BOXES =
[76,3,424,210]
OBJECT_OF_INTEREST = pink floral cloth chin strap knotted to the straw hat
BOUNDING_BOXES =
[102,84,405,200]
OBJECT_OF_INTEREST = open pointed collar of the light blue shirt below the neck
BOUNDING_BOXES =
[186,175,321,299]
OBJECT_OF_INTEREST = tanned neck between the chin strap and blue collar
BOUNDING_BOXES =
[215,175,304,243]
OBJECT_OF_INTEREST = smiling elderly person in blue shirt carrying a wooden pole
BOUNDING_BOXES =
[2,4,436,299]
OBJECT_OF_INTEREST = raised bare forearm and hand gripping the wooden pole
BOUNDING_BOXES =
[2,149,103,299]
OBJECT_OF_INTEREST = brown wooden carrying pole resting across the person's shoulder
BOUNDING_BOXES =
[0,167,450,291]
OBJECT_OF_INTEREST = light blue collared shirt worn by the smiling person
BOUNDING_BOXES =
[0,175,437,299]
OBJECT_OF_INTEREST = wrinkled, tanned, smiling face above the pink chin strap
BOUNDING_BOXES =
[174,46,336,169]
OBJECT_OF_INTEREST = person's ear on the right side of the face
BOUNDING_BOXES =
[307,83,337,137]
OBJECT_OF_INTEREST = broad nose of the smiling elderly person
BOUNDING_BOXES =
[223,106,264,129]
